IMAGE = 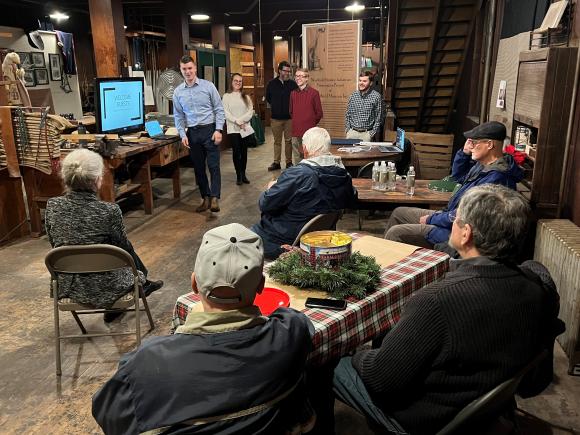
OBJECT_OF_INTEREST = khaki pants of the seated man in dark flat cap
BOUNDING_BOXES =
[385,207,435,249]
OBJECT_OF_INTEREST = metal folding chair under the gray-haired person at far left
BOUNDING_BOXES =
[45,245,155,376]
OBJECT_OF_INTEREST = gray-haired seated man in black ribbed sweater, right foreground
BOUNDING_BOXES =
[334,184,563,435]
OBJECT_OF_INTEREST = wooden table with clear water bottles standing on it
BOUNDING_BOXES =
[352,178,451,209]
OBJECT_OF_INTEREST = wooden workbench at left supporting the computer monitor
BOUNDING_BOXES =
[21,138,188,237]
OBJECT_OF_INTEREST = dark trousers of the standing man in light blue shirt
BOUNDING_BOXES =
[187,124,222,198]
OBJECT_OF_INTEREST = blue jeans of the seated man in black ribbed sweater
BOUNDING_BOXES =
[333,356,407,435]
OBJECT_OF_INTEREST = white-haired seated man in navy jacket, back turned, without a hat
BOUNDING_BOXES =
[252,127,356,260]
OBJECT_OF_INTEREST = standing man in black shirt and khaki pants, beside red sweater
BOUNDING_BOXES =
[266,61,298,171]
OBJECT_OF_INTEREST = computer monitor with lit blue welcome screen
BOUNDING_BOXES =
[95,77,145,134]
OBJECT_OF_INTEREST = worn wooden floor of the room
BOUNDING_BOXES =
[0,136,580,435]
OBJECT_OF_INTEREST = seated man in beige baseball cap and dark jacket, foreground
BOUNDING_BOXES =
[93,223,315,434]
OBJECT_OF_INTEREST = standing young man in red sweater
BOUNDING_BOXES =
[290,68,322,165]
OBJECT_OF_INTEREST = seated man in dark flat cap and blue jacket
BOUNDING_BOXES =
[385,121,523,248]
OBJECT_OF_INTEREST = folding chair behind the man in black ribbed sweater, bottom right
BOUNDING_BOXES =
[437,350,548,435]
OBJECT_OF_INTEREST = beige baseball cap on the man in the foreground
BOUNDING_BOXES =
[194,223,264,305]
